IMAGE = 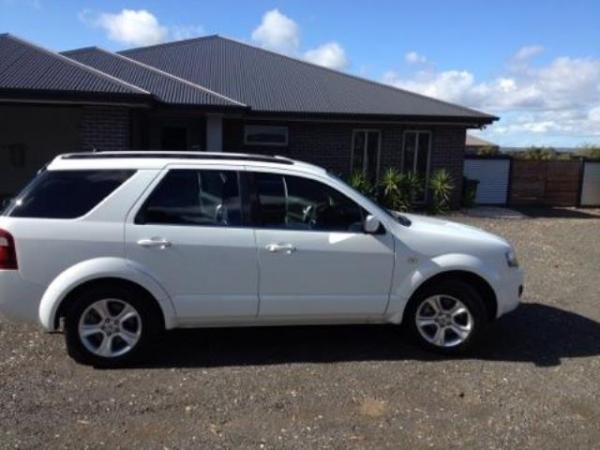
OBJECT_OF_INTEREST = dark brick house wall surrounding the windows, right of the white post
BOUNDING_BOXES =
[223,119,466,207]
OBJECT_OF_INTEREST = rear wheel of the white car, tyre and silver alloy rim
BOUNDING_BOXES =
[65,286,159,367]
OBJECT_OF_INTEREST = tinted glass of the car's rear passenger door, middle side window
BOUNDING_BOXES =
[136,170,242,226]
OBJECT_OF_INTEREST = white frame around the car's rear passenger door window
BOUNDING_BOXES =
[130,165,252,229]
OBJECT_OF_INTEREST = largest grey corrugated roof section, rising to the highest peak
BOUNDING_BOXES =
[120,36,497,123]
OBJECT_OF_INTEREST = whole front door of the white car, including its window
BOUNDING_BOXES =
[249,172,394,322]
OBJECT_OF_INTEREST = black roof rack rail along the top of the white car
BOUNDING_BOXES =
[61,150,294,164]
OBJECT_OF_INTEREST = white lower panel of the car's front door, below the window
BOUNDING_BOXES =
[256,229,394,319]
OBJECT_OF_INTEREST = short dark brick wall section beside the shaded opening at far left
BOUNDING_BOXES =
[80,106,131,150]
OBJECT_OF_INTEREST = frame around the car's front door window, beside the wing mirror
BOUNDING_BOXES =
[243,168,372,235]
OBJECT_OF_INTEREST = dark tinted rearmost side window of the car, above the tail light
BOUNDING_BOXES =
[4,170,135,219]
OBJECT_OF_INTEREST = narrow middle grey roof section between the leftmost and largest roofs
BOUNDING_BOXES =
[62,47,246,108]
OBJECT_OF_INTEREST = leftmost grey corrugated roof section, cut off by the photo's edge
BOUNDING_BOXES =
[0,34,150,99]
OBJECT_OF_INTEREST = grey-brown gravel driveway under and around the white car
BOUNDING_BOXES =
[0,212,600,449]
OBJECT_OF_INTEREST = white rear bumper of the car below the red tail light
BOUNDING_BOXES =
[0,270,44,323]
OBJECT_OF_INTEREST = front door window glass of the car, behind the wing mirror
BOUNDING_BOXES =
[254,173,365,232]
